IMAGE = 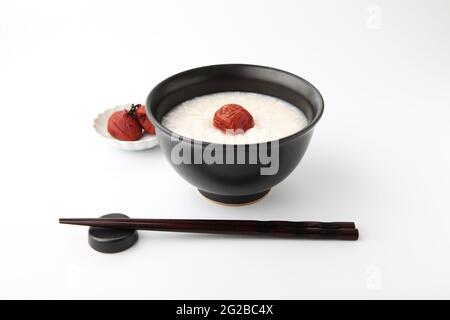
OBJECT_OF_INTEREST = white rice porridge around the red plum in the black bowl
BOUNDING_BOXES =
[162,91,308,144]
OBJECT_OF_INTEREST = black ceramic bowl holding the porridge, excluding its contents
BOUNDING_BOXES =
[146,64,323,204]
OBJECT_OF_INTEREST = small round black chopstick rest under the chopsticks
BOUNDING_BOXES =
[88,213,138,253]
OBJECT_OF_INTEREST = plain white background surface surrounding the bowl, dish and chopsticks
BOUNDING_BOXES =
[0,0,450,299]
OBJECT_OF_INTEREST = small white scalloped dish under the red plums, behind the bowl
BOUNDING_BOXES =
[94,104,158,151]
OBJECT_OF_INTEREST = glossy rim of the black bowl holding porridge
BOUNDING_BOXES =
[145,63,324,146]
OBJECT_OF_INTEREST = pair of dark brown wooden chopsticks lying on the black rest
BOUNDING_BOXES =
[59,218,359,240]
